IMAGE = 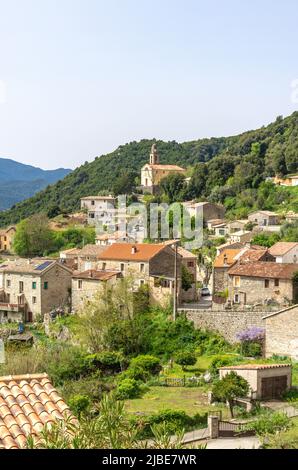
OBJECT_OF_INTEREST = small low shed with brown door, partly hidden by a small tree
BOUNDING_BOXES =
[219,364,292,400]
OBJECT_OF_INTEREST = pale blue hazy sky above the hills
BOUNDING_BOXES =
[0,0,298,169]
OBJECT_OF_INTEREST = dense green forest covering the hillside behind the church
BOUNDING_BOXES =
[0,112,298,226]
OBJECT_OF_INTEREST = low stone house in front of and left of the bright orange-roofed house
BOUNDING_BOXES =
[71,270,121,312]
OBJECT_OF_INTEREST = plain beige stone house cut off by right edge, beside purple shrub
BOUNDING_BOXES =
[264,305,298,361]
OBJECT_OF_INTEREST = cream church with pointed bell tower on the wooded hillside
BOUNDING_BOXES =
[141,144,186,194]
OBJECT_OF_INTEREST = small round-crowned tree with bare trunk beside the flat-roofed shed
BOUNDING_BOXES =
[212,372,249,418]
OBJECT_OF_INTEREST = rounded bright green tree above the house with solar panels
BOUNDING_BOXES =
[13,214,53,256]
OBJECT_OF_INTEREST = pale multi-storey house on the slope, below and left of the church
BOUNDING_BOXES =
[81,196,116,225]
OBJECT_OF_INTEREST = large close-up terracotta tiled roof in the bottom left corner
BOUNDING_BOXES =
[0,374,72,449]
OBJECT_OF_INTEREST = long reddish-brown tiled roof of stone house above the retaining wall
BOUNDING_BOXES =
[229,261,298,279]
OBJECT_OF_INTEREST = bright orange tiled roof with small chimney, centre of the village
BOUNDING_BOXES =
[99,243,167,261]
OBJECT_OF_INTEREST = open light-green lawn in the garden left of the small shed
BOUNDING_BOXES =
[125,387,228,416]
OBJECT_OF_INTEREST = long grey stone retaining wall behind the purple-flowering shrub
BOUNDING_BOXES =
[179,309,268,343]
